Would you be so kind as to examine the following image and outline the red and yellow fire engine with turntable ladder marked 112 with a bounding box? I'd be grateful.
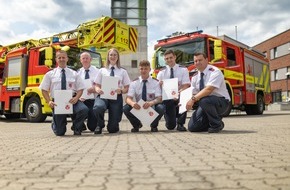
[0,17,138,122]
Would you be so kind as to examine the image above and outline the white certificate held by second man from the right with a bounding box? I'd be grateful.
[162,78,178,100]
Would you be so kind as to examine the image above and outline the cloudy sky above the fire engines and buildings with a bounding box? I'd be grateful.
[0,0,290,60]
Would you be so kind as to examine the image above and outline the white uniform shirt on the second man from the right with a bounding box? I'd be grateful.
[157,64,190,89]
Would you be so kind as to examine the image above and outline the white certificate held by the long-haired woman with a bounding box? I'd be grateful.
[100,76,119,100]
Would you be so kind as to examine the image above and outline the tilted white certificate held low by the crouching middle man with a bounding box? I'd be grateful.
[131,99,158,126]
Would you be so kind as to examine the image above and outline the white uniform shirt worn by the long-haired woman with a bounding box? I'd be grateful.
[94,66,131,88]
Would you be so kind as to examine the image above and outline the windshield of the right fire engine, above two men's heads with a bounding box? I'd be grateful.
[155,39,206,68]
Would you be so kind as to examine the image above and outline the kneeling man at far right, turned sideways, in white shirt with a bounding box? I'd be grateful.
[186,53,231,133]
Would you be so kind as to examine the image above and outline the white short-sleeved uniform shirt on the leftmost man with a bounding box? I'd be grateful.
[39,67,85,98]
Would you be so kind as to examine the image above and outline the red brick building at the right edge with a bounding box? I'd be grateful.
[253,29,290,102]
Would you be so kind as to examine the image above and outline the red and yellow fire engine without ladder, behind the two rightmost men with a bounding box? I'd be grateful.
[151,31,272,116]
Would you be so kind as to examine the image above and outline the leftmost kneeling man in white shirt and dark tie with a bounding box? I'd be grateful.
[39,50,88,136]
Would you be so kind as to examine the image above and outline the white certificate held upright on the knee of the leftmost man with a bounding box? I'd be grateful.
[54,90,73,114]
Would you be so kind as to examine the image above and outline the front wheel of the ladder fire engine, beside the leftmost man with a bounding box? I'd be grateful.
[25,97,47,123]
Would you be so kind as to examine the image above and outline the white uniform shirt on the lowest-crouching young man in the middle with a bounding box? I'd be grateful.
[127,77,161,102]
